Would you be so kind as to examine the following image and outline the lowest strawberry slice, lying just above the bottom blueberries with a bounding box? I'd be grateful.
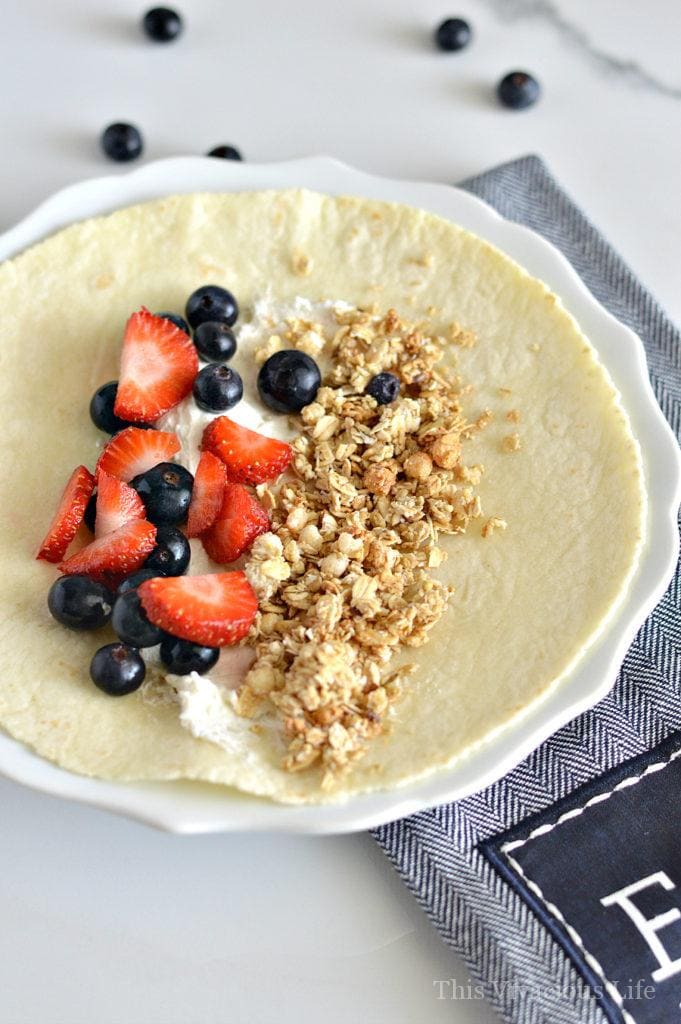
[137,572,258,647]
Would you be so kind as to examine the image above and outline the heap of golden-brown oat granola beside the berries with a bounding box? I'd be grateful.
[236,309,491,787]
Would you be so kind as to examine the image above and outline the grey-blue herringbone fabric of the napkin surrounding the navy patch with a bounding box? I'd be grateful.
[375,157,681,1024]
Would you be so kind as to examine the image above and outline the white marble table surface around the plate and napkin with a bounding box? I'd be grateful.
[0,0,681,1024]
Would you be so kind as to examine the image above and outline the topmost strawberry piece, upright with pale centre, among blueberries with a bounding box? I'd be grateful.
[114,306,199,423]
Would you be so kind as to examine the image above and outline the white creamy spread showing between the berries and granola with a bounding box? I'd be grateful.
[141,296,349,753]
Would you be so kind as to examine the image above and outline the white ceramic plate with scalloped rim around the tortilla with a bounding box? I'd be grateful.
[0,157,681,833]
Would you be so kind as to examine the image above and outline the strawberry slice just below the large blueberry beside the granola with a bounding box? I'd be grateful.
[201,416,293,483]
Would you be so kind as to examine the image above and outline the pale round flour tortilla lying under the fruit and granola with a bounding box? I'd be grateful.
[0,190,644,802]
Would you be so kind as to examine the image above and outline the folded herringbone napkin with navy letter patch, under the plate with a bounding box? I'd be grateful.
[375,156,681,1024]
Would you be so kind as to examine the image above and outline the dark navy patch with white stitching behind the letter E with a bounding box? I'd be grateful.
[480,732,681,1024]
